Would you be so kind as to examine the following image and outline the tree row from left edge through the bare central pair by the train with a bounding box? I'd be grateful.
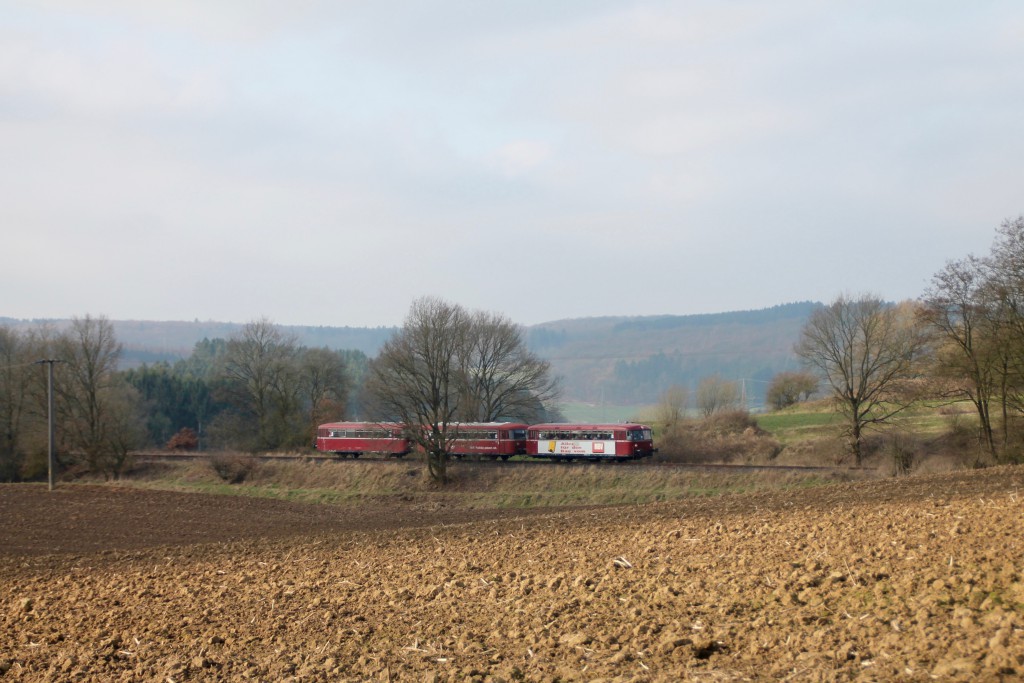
[0,299,556,481]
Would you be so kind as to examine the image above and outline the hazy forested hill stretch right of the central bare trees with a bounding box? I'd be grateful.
[528,301,820,407]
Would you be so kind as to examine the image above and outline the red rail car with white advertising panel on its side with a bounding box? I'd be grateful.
[526,422,654,461]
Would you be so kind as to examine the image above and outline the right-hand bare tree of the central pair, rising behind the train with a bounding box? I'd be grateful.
[460,311,558,422]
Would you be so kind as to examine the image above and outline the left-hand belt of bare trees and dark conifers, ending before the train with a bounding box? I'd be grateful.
[0,315,366,480]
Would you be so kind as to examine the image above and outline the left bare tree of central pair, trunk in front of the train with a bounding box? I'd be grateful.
[367,297,470,483]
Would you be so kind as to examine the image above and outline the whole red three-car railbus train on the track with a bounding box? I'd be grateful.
[315,422,655,461]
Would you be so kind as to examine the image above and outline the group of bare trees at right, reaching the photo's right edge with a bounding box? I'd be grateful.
[796,216,1024,464]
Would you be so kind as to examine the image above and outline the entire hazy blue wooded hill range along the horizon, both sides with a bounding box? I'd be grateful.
[0,301,820,408]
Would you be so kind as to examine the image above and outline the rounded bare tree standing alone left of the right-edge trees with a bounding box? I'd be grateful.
[796,295,926,465]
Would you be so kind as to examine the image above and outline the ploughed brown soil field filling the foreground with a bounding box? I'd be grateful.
[0,468,1024,681]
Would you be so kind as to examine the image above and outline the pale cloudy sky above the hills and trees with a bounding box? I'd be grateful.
[0,0,1024,327]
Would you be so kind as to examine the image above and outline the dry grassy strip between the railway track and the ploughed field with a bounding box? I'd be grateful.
[122,460,871,508]
